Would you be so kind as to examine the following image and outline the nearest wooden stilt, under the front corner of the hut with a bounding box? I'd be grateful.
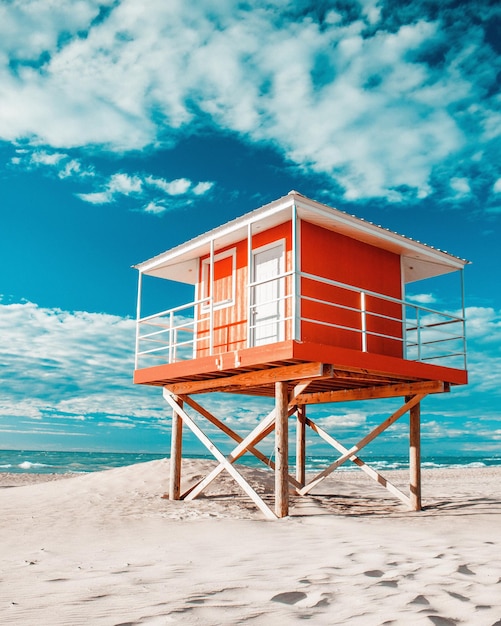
[275,382,289,517]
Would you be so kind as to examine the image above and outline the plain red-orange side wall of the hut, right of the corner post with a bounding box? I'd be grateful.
[301,222,402,356]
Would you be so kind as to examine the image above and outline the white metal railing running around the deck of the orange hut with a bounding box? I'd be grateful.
[136,272,466,369]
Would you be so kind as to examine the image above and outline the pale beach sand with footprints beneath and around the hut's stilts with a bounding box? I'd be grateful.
[0,461,501,626]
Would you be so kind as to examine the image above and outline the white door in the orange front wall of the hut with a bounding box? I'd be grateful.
[250,242,285,346]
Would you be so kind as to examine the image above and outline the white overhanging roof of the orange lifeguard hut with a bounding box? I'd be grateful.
[134,191,468,284]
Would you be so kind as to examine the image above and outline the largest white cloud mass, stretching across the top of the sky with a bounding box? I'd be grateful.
[0,0,499,201]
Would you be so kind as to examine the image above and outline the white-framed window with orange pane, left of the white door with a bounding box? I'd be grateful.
[202,248,236,311]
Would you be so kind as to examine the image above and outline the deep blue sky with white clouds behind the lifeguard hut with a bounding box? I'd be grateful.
[0,0,501,455]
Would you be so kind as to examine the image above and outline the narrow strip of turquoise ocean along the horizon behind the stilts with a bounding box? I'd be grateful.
[0,450,501,474]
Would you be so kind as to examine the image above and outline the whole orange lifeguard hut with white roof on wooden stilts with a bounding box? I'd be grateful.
[134,191,467,518]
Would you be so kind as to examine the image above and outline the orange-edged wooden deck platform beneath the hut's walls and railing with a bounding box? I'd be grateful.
[134,341,468,394]
